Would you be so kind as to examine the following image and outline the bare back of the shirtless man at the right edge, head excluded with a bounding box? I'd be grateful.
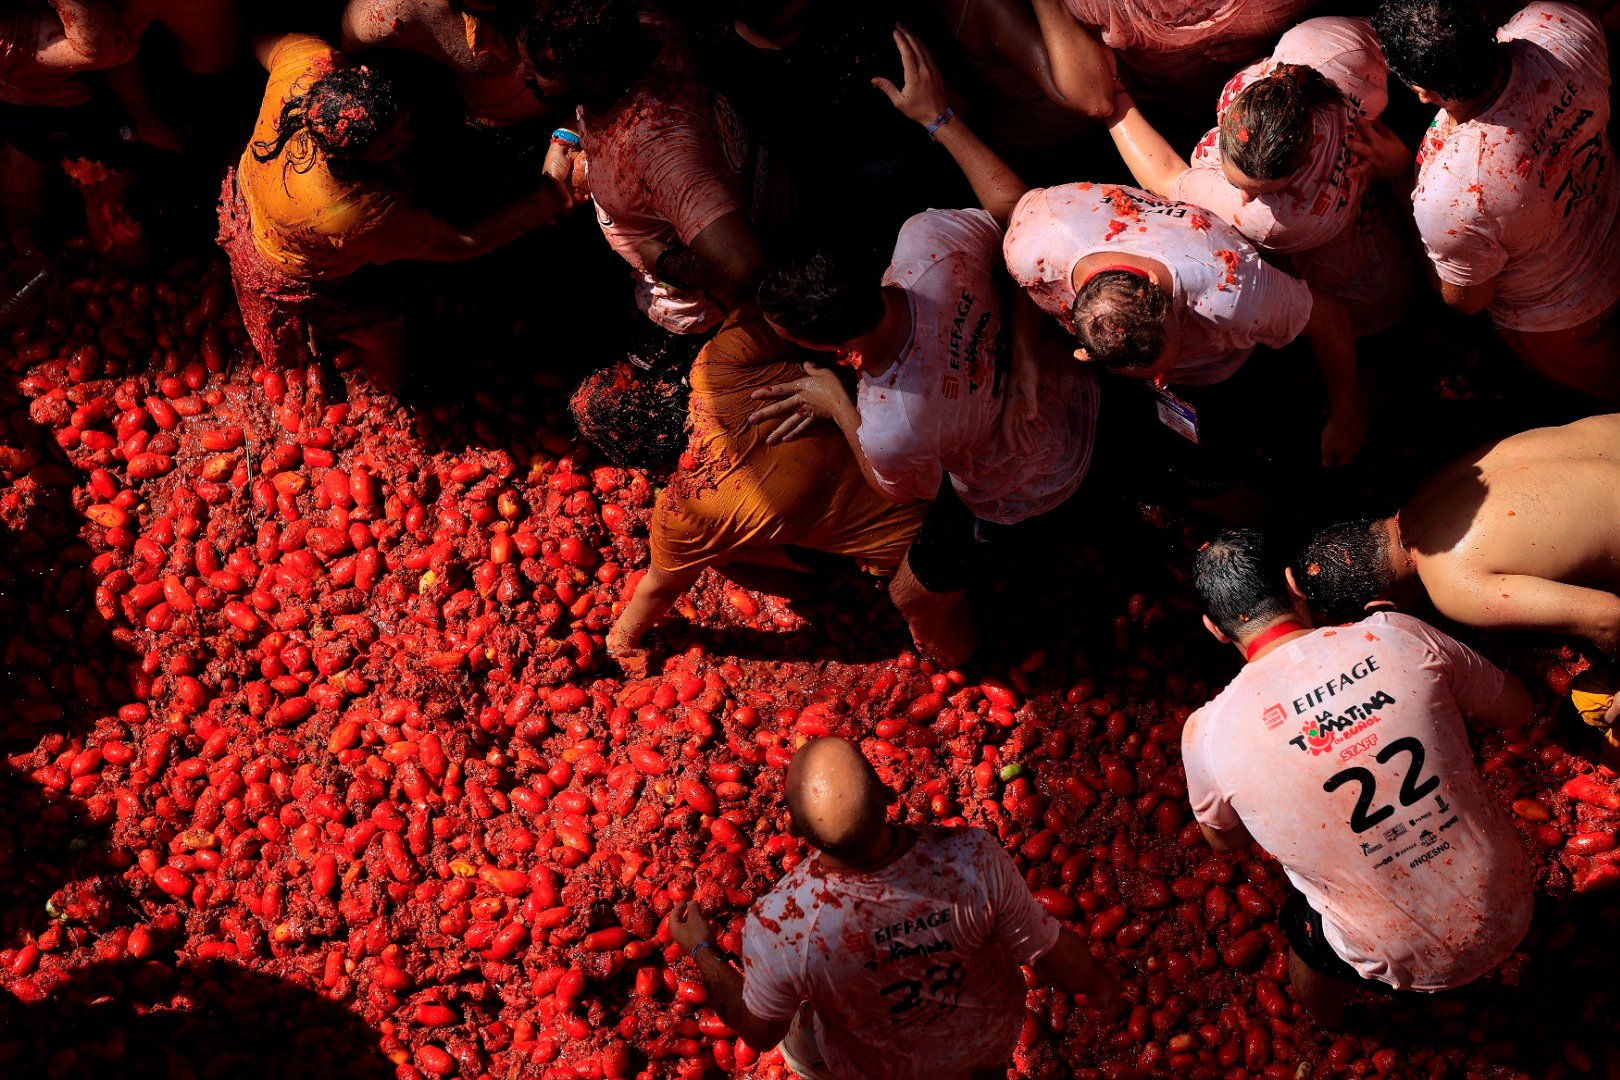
[1401,415,1620,649]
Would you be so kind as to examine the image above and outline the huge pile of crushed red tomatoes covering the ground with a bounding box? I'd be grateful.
[0,244,1620,1080]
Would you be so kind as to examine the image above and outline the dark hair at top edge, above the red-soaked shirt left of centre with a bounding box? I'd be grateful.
[517,0,658,107]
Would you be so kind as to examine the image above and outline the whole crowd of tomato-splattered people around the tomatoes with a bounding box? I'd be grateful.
[0,0,1620,1078]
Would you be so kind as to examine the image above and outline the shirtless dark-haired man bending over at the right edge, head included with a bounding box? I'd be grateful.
[1294,415,1620,656]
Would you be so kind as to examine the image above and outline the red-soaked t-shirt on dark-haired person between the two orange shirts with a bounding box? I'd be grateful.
[578,15,758,334]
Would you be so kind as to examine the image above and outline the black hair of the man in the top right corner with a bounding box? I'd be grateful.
[1372,0,1502,100]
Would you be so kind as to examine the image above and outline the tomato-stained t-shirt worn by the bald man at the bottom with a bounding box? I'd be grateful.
[742,827,1059,1080]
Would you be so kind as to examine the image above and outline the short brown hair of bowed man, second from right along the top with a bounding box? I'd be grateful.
[1220,63,1345,181]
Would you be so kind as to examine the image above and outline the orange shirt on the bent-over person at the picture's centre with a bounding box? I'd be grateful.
[651,309,928,575]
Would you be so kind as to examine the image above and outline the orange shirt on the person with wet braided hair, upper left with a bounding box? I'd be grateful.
[237,34,434,280]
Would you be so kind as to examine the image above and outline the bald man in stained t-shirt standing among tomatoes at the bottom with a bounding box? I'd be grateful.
[669,738,1119,1080]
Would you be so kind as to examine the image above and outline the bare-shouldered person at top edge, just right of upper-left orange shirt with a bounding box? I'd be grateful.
[342,0,552,128]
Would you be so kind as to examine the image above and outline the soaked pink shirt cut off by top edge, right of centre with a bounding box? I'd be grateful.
[1064,0,1315,89]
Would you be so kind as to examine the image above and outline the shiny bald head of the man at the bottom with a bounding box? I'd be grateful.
[786,737,893,868]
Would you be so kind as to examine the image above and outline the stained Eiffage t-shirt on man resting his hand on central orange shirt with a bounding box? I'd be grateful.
[855,209,1098,525]
